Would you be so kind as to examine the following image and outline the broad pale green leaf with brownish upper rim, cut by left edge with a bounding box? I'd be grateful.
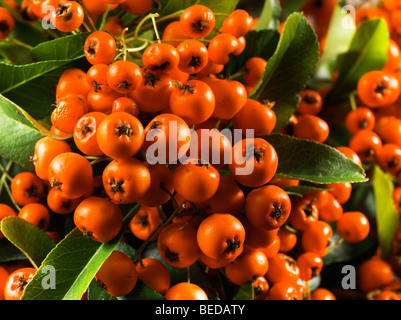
[0,95,46,171]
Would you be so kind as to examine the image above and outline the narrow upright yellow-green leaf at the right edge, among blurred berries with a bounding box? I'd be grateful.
[372,165,400,258]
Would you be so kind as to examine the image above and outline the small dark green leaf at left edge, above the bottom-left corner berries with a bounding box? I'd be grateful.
[1,216,56,268]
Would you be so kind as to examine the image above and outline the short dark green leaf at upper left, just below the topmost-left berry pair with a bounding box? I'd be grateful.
[32,33,90,61]
